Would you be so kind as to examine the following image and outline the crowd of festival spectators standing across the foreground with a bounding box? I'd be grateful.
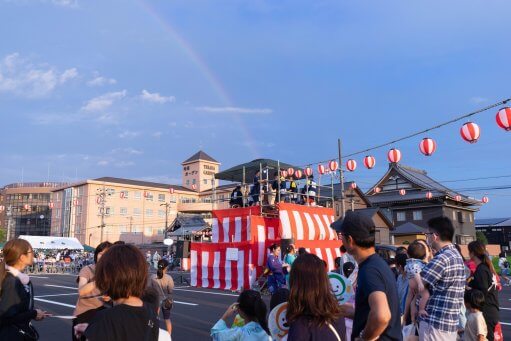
[0,212,506,341]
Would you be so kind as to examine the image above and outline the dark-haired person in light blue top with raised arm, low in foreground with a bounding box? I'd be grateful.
[211,290,271,341]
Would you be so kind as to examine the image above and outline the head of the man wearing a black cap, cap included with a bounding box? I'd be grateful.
[331,211,376,254]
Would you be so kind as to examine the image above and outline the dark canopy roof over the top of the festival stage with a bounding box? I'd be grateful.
[215,159,298,183]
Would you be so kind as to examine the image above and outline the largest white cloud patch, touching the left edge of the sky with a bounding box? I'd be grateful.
[0,53,78,98]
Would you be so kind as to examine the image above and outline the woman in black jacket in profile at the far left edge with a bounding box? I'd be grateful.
[0,239,49,341]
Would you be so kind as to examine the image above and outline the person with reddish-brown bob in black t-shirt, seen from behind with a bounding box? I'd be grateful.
[75,245,159,341]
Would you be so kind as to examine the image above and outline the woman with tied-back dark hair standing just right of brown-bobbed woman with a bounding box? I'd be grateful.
[151,259,174,334]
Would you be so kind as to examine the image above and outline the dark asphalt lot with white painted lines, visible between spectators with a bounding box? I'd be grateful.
[31,273,511,341]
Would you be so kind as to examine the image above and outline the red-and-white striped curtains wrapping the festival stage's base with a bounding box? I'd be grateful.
[191,203,341,290]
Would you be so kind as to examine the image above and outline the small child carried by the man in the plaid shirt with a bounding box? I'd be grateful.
[405,241,430,323]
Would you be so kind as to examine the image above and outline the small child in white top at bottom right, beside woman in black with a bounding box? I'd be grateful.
[464,289,488,341]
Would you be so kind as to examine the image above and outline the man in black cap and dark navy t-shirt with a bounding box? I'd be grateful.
[331,212,402,341]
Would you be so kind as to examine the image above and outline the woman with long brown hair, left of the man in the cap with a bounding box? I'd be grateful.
[287,254,346,341]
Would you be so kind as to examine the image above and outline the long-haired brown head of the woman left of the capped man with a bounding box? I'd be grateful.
[287,253,340,326]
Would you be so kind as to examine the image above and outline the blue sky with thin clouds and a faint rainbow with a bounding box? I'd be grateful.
[0,0,511,217]
